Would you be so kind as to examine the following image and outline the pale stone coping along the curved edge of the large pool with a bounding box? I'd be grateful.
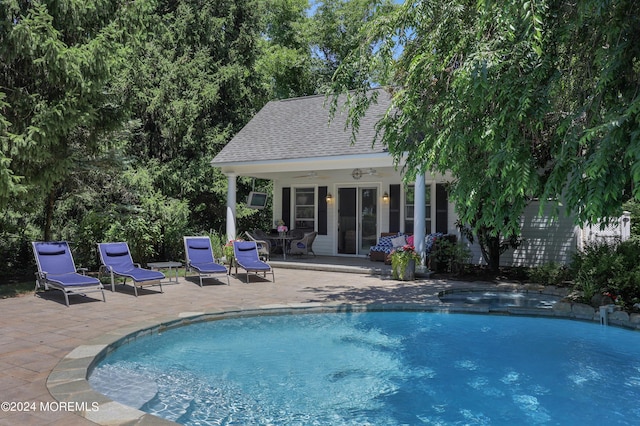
[46,298,640,425]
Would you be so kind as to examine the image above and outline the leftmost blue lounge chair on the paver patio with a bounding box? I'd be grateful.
[31,241,107,307]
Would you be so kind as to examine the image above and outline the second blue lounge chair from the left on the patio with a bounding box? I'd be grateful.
[98,242,165,297]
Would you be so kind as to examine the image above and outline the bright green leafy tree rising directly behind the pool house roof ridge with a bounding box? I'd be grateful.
[257,0,395,100]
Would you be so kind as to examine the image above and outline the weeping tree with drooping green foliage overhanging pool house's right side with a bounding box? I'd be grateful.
[334,0,640,269]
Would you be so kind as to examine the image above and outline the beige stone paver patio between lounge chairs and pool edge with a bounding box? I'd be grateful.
[0,266,608,425]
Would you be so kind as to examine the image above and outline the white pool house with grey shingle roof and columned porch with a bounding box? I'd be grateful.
[211,92,444,268]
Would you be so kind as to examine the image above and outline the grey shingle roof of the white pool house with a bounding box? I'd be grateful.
[211,91,390,165]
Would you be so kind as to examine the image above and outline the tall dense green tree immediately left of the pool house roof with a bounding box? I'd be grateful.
[116,0,265,235]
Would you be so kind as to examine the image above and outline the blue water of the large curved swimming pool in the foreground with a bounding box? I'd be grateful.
[89,312,640,425]
